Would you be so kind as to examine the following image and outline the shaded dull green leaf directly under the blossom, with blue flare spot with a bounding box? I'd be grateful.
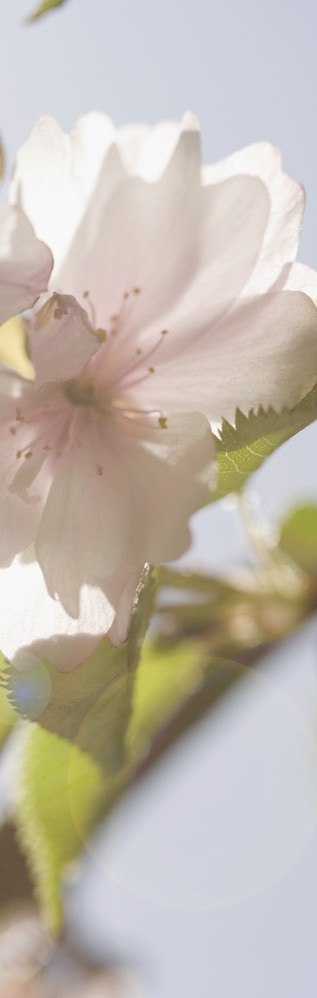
[6,566,155,776]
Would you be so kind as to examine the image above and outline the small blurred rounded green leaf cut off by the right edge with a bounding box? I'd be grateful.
[279,504,317,575]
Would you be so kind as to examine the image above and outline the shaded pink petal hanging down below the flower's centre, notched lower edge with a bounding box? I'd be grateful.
[36,413,213,630]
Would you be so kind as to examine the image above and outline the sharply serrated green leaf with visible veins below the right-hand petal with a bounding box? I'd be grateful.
[211,386,317,501]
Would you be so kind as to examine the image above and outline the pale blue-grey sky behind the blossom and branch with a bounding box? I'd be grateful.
[0,0,317,998]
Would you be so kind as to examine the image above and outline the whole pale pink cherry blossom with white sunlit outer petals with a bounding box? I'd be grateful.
[0,113,317,670]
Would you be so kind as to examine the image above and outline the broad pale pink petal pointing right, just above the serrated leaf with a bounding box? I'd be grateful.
[133,291,317,422]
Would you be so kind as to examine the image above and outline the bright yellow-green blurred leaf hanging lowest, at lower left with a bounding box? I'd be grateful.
[14,724,102,932]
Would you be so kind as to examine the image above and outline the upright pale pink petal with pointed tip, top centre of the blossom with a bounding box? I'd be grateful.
[53,114,203,328]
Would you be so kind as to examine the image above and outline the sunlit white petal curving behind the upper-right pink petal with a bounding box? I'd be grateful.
[203,142,305,296]
